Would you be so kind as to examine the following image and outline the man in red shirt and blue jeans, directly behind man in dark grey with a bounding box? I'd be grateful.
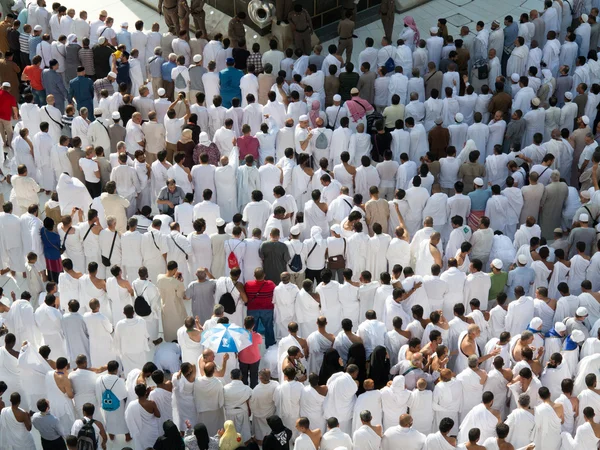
[244,267,275,348]
